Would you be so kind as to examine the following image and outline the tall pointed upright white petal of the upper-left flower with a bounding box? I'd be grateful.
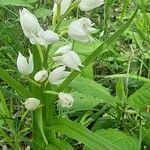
[20,8,42,38]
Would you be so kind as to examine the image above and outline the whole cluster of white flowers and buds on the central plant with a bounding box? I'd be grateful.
[17,0,103,110]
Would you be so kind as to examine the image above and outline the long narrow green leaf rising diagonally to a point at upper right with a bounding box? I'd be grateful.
[57,9,138,92]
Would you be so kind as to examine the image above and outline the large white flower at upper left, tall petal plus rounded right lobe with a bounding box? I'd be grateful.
[20,8,59,47]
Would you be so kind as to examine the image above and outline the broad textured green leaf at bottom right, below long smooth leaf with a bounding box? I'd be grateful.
[85,129,139,150]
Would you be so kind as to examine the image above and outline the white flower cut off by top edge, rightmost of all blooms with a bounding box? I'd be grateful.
[78,0,104,11]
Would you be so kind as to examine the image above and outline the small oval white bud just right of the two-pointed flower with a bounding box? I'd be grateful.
[34,70,48,82]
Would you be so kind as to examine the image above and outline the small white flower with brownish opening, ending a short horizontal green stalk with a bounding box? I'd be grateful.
[58,92,74,108]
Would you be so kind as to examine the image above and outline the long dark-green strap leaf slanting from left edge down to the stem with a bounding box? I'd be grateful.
[0,67,32,98]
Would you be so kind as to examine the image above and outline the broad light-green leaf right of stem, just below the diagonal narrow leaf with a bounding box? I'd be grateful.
[69,77,114,102]
